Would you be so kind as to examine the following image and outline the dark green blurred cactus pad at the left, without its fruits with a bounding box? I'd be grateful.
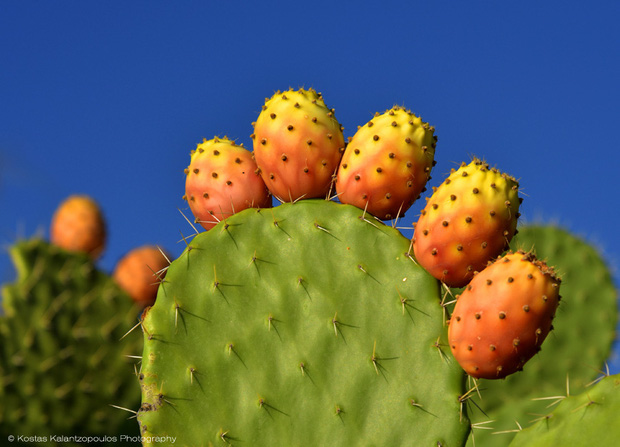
[0,239,142,439]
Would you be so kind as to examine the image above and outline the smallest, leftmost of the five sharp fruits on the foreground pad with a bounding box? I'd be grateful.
[183,137,271,230]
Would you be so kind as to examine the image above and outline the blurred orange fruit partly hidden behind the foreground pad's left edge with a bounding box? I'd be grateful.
[113,245,170,307]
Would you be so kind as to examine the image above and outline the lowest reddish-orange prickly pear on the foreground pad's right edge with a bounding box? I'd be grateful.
[448,251,560,379]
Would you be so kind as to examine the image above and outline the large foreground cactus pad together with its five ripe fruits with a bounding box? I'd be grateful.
[138,89,616,446]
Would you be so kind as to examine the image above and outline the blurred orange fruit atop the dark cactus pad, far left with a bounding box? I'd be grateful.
[50,195,106,259]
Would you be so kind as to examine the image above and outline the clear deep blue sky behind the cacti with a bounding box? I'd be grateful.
[0,0,620,371]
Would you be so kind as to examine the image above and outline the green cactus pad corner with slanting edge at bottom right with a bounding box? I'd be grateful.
[510,375,620,447]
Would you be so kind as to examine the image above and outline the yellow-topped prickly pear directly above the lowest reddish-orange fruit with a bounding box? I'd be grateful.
[413,159,521,287]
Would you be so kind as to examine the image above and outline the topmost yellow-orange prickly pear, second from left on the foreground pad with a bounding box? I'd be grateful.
[252,89,344,202]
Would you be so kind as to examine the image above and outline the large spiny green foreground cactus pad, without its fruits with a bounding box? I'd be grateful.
[138,200,469,446]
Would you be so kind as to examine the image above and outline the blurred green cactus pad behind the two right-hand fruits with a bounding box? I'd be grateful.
[469,225,617,447]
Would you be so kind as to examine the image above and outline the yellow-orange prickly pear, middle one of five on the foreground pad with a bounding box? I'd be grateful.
[336,107,437,220]
